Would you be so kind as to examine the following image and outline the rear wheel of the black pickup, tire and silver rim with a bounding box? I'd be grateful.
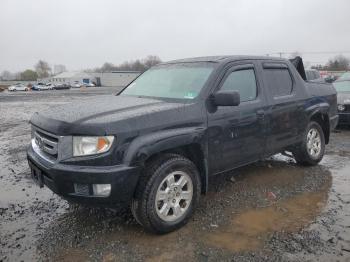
[293,121,325,166]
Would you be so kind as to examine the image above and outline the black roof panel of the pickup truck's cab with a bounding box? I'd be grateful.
[162,55,286,64]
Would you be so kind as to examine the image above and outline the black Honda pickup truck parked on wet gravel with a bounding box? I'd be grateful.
[27,56,338,233]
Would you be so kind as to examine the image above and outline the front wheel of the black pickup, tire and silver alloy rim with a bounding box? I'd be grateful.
[131,154,201,234]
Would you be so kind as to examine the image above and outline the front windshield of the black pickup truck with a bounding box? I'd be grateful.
[121,63,214,99]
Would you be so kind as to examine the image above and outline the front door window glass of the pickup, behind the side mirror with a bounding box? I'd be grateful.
[220,69,257,102]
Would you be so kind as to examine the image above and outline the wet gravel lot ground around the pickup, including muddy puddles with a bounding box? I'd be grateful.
[0,88,350,261]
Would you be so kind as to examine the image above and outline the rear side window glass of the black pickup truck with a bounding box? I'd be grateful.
[264,68,293,97]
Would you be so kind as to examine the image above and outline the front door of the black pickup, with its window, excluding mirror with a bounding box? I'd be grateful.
[208,63,267,174]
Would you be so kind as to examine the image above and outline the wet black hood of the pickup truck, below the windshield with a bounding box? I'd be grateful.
[30,96,200,135]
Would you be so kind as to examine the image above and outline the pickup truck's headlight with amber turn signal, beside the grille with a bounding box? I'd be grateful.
[73,136,114,156]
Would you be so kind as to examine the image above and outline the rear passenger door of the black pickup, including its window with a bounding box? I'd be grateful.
[261,61,304,155]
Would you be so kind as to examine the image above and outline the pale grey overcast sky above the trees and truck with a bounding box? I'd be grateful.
[0,0,350,71]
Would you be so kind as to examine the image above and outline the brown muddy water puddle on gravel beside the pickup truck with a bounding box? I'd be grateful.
[205,180,330,252]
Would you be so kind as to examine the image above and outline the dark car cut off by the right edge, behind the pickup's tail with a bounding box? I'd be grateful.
[333,73,350,125]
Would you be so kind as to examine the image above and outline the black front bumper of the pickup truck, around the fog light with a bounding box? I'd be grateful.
[27,146,140,206]
